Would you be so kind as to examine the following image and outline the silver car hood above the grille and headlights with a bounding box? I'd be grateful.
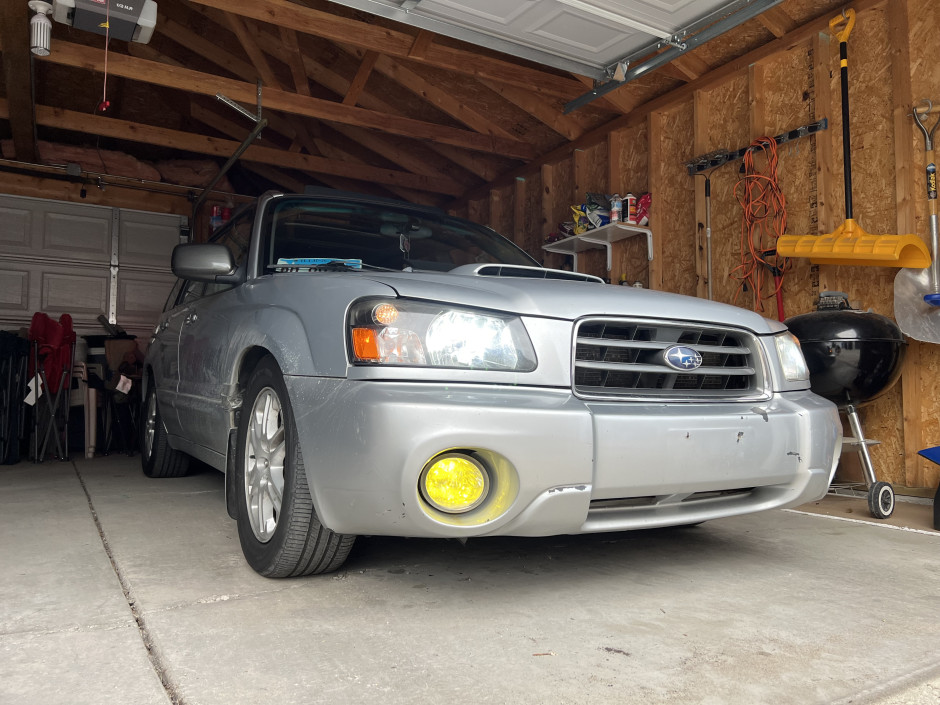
[363,272,785,334]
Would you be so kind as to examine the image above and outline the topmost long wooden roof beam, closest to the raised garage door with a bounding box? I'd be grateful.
[185,0,583,100]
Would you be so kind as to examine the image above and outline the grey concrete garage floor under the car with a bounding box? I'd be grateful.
[0,456,940,705]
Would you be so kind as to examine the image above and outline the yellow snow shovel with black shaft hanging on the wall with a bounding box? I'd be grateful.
[777,10,930,269]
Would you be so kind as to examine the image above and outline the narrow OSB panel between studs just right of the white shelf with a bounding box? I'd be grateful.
[650,100,697,296]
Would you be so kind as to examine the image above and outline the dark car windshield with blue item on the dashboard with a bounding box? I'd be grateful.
[262,197,539,272]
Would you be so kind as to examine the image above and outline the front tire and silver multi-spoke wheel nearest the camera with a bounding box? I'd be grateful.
[233,357,356,578]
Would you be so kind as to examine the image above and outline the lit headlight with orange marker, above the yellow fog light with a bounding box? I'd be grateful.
[349,299,536,372]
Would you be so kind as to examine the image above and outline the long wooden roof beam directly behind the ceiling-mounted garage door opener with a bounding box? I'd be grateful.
[43,42,535,160]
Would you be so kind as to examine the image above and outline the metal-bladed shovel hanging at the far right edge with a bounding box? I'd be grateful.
[894,99,940,343]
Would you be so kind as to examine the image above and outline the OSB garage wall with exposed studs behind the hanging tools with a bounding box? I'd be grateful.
[458,0,940,492]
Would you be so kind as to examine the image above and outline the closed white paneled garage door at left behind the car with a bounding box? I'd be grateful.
[0,195,182,337]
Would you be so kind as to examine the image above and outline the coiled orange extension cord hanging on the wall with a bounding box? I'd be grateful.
[730,137,790,321]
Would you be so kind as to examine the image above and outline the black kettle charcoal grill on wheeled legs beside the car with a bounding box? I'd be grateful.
[786,309,907,519]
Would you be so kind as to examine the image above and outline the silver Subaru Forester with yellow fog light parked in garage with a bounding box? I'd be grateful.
[141,191,842,577]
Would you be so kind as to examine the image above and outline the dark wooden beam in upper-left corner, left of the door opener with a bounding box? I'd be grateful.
[0,0,39,164]
